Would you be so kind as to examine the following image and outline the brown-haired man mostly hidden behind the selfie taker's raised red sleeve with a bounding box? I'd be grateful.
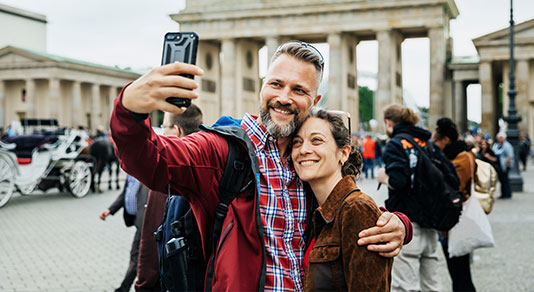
[135,104,202,292]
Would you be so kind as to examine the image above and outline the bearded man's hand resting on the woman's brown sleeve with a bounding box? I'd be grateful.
[358,212,406,258]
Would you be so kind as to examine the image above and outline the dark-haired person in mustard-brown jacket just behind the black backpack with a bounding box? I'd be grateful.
[440,140,477,292]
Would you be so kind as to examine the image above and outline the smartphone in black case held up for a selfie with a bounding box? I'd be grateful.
[161,32,198,107]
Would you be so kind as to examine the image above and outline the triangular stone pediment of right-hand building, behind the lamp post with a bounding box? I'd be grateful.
[473,19,534,46]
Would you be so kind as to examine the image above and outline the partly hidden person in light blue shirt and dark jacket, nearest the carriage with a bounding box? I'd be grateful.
[100,175,148,292]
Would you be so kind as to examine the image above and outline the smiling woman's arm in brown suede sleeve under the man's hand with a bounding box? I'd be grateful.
[340,199,393,291]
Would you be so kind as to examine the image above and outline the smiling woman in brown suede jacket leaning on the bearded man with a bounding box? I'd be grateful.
[291,108,393,291]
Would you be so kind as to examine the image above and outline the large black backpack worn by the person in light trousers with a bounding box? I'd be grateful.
[397,134,462,231]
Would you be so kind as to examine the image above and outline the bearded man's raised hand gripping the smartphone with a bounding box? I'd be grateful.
[122,63,204,114]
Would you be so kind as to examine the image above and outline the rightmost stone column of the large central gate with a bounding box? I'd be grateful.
[428,27,448,129]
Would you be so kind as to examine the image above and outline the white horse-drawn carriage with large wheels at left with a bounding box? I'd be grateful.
[0,119,92,207]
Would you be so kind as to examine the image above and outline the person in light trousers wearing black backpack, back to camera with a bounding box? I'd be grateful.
[377,105,462,291]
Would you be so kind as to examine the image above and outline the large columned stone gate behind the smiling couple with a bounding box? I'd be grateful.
[171,0,458,130]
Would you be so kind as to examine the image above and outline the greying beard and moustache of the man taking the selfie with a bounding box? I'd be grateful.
[260,101,300,138]
